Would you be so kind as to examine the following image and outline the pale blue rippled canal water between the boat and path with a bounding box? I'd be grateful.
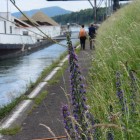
[0,30,78,107]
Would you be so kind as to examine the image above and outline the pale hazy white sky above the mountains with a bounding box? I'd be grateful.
[0,0,104,12]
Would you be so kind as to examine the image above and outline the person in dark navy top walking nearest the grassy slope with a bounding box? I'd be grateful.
[88,24,96,49]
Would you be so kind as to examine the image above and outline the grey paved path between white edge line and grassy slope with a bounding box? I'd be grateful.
[2,40,94,140]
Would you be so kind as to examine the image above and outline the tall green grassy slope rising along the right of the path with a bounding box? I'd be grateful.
[88,0,140,140]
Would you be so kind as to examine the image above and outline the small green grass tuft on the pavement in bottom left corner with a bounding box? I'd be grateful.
[0,126,21,135]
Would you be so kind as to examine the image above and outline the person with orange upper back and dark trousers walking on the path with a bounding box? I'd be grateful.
[79,25,87,50]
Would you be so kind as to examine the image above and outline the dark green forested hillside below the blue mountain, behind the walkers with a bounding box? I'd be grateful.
[53,8,106,25]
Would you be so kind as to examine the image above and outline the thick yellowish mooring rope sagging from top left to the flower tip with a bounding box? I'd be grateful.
[10,0,67,47]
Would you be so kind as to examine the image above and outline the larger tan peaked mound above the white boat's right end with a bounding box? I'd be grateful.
[32,11,59,26]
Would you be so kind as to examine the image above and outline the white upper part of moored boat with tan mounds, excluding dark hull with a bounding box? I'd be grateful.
[0,12,61,45]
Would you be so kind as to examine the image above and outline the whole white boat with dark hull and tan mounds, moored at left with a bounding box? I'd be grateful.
[0,12,61,60]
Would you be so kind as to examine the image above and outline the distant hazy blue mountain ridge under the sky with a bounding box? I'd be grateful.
[12,6,72,18]
